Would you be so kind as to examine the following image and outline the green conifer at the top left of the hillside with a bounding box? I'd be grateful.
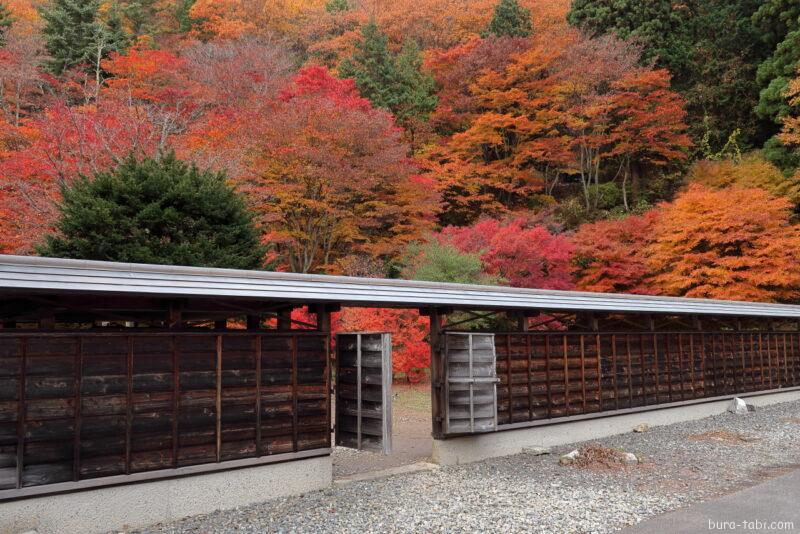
[40,0,127,74]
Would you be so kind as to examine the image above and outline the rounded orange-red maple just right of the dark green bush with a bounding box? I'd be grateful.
[239,67,435,272]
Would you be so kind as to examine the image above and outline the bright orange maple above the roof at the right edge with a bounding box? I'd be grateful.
[647,184,800,302]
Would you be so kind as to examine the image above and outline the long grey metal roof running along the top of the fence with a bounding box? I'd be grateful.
[0,255,800,318]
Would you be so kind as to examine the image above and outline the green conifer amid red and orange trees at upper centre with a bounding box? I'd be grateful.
[339,22,437,131]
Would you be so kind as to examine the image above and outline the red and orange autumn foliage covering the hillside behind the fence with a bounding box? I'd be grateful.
[0,0,800,350]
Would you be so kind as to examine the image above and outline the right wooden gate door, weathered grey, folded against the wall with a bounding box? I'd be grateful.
[444,332,498,434]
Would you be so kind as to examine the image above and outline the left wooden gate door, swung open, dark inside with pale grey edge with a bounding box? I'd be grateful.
[335,332,392,454]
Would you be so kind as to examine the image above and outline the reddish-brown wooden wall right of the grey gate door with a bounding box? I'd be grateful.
[495,332,800,425]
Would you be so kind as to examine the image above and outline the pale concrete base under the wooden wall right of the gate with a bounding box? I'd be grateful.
[433,391,800,465]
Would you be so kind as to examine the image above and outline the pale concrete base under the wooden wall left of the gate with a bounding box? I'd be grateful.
[0,456,332,534]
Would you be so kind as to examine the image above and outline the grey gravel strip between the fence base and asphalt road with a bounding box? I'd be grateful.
[130,402,800,533]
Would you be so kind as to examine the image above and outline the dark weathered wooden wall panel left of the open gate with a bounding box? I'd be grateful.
[0,332,330,496]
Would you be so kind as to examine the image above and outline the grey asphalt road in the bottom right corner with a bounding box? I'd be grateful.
[622,470,800,534]
